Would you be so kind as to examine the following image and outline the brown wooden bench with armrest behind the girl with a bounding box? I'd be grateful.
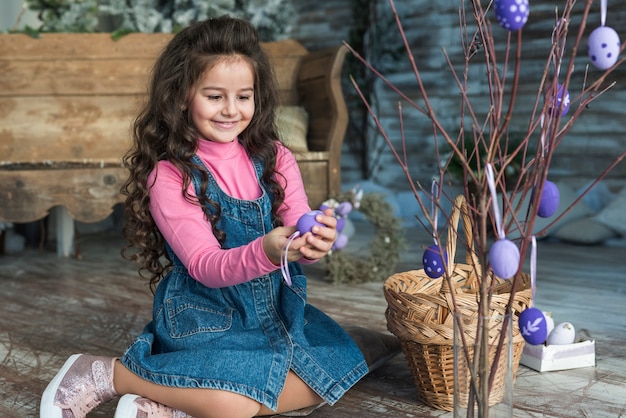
[0,33,348,255]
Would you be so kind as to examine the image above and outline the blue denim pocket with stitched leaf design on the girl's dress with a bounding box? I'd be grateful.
[166,297,233,338]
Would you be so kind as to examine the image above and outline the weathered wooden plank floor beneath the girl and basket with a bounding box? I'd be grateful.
[0,222,626,418]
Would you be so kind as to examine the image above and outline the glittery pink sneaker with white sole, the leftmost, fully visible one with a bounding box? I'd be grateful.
[39,354,117,418]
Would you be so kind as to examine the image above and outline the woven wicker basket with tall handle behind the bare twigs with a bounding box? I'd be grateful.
[383,196,532,411]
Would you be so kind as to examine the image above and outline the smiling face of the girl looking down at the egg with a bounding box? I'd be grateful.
[189,56,255,143]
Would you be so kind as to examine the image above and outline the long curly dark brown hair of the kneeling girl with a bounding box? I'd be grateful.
[121,17,285,290]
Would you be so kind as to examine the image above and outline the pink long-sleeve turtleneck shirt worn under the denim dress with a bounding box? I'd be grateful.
[148,139,310,287]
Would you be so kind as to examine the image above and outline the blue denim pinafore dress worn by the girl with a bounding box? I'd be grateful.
[122,156,368,410]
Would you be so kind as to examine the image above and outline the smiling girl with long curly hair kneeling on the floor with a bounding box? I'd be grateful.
[41,17,397,418]
